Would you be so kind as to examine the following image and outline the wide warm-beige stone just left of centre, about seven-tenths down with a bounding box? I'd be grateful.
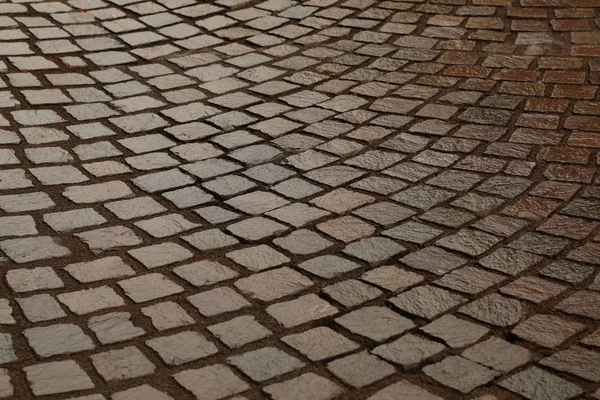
[235,267,314,301]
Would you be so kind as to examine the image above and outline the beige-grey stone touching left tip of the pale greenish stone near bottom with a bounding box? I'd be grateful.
[146,331,218,365]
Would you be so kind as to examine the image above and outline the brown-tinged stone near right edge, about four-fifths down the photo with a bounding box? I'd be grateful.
[512,314,585,348]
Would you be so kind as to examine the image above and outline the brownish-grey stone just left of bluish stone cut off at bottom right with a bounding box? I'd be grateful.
[423,356,499,394]
